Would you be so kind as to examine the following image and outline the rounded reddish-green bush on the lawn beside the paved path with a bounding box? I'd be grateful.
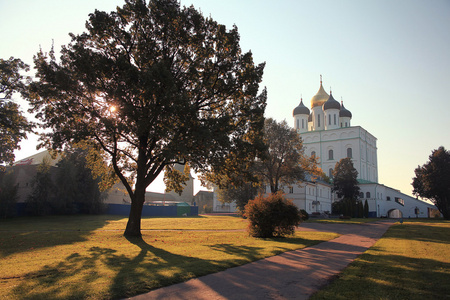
[245,192,301,238]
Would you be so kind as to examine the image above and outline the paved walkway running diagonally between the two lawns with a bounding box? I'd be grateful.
[127,220,394,300]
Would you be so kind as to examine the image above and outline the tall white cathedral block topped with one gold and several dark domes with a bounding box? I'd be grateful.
[293,76,378,183]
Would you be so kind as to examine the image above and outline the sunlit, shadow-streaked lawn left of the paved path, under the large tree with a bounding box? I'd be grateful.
[0,216,337,299]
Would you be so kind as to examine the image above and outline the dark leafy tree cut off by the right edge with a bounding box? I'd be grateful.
[412,146,450,220]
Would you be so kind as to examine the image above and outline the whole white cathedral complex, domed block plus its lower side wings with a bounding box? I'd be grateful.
[214,76,436,218]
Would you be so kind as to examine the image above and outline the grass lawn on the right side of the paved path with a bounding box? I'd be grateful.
[311,219,450,300]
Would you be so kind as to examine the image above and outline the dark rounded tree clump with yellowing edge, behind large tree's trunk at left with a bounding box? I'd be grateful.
[26,143,114,215]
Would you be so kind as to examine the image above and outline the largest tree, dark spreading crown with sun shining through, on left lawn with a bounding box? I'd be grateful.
[30,0,266,236]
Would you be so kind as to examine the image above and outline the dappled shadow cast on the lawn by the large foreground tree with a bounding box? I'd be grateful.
[6,238,250,299]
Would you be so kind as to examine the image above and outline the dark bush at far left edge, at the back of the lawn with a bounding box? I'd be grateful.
[0,171,18,219]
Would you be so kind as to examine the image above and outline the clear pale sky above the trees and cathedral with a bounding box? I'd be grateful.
[0,0,450,194]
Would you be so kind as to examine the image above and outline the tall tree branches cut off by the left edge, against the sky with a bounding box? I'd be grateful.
[0,57,33,167]
